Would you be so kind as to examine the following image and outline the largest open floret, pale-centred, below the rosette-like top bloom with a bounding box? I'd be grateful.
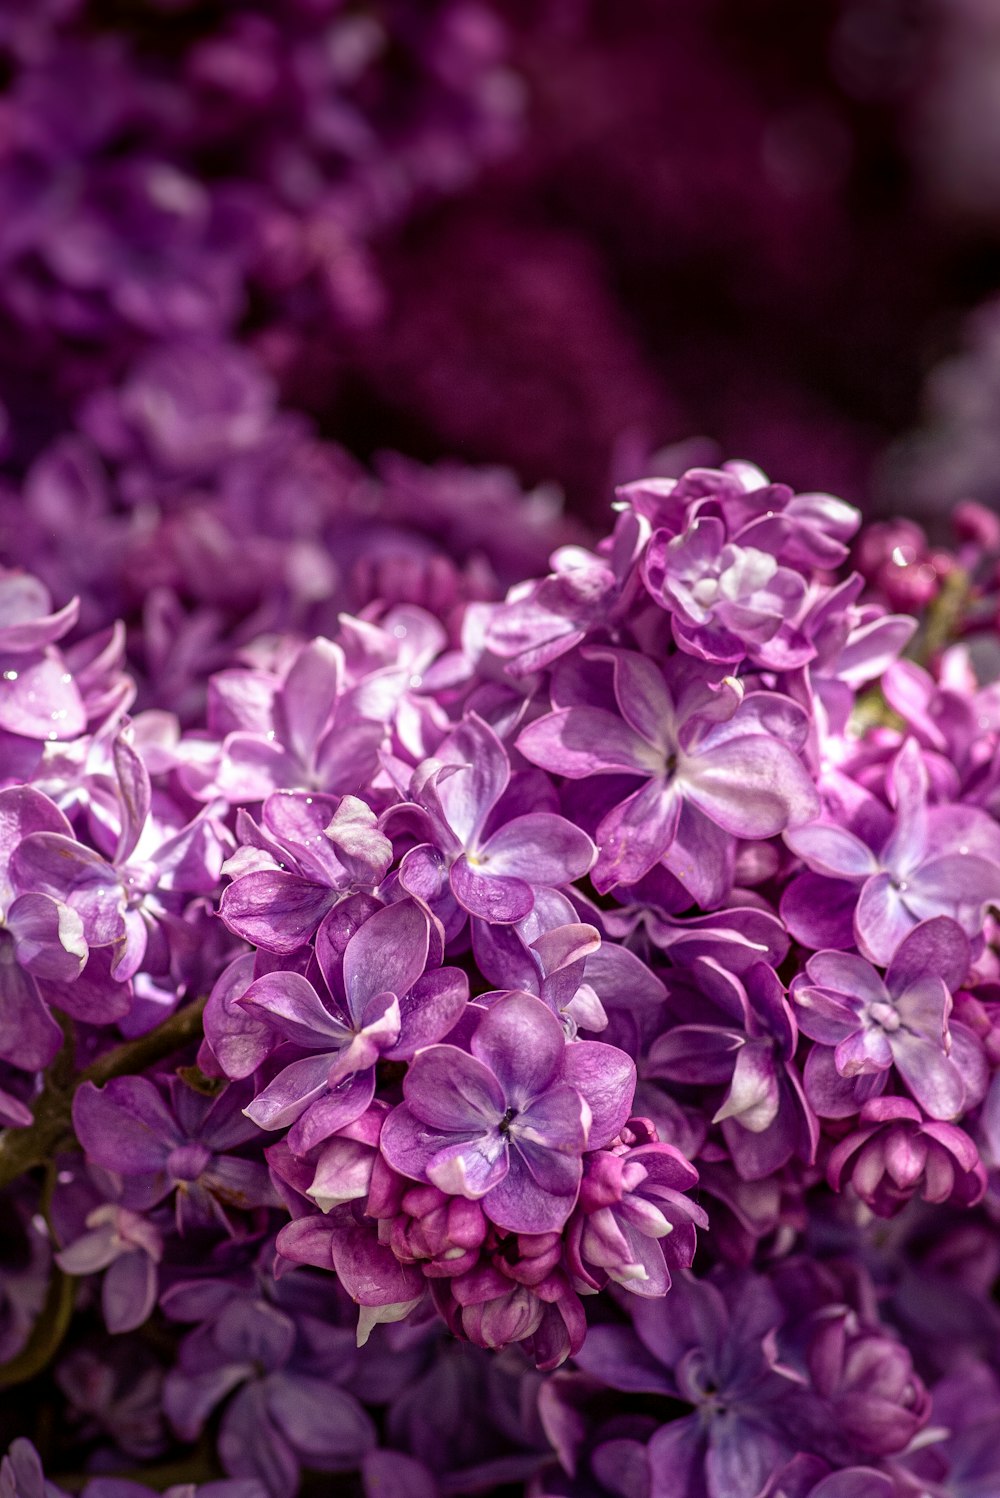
[518,650,817,906]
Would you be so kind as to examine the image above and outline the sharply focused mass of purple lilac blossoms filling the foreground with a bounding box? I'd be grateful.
[0,449,1000,1498]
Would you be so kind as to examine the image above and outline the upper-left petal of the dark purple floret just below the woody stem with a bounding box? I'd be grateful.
[73,1077,184,1176]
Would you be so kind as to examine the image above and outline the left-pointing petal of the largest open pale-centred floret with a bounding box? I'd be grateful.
[518,707,665,780]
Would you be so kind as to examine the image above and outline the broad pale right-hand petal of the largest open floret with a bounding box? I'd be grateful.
[678,734,819,837]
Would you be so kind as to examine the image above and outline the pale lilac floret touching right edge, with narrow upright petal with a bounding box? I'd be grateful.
[781,739,1000,966]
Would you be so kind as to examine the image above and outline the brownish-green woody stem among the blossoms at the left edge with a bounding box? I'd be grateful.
[0,998,205,1188]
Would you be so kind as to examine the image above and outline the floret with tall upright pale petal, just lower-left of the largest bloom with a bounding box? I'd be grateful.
[383,713,594,927]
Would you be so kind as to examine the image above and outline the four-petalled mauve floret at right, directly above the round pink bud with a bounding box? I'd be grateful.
[792,915,987,1119]
